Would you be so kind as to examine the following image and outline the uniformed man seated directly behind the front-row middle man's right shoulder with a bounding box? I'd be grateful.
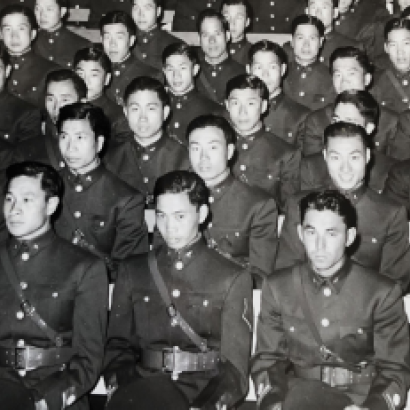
[187,115,278,287]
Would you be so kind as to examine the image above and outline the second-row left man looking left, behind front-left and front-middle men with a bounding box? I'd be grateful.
[56,103,148,280]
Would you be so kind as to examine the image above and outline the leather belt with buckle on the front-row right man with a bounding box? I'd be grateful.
[295,366,376,387]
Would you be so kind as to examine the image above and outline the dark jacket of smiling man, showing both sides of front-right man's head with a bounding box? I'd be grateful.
[275,185,410,293]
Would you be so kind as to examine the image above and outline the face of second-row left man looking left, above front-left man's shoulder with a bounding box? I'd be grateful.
[58,120,104,174]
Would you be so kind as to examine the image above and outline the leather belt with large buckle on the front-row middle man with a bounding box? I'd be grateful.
[141,346,220,373]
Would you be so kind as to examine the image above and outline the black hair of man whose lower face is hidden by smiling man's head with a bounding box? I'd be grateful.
[334,90,379,125]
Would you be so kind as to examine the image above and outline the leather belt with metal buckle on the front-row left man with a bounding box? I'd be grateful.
[0,346,74,370]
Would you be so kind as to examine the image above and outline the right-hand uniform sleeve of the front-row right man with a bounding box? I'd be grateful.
[363,285,410,410]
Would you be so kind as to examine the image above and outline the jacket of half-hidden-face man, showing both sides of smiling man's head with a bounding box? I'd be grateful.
[301,104,403,158]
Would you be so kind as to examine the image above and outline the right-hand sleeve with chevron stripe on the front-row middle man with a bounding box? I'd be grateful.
[192,272,253,410]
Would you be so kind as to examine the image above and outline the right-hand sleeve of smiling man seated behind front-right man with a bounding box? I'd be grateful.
[380,207,410,293]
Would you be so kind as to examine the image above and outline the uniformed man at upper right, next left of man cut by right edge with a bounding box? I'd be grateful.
[283,15,334,110]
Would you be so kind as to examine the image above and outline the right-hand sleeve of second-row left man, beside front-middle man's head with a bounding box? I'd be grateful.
[111,194,148,260]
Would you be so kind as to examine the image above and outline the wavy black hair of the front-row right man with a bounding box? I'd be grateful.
[299,189,357,229]
